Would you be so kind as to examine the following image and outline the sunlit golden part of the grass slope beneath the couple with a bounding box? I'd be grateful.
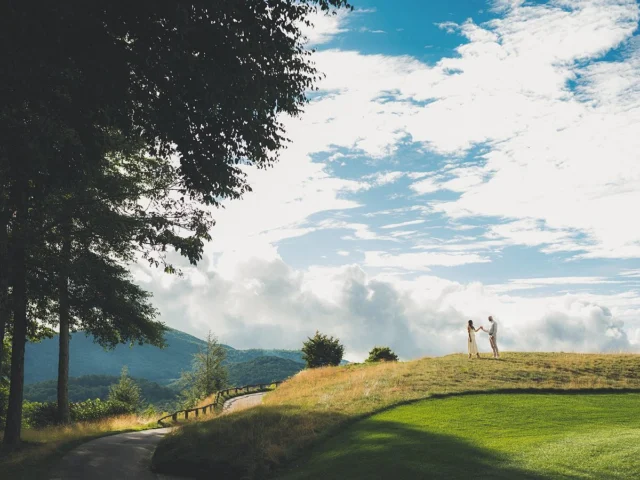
[264,353,640,416]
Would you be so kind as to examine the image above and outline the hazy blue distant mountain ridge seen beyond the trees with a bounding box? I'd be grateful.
[25,329,304,385]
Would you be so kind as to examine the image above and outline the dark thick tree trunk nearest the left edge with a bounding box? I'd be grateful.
[4,180,29,447]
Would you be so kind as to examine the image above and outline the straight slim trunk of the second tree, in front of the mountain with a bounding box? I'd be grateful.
[58,221,71,423]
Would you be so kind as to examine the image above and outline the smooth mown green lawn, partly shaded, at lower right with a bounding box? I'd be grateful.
[277,394,640,480]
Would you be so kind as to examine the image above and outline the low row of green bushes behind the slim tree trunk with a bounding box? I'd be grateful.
[22,399,134,428]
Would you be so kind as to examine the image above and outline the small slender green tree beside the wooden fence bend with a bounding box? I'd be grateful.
[180,332,228,407]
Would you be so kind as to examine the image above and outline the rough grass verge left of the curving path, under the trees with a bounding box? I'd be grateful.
[0,415,158,480]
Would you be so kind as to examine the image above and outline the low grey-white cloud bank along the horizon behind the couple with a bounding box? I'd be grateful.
[140,258,640,360]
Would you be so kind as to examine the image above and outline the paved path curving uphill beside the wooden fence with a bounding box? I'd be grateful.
[49,393,264,480]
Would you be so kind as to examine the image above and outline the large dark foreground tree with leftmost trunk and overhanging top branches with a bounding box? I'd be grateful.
[0,0,348,445]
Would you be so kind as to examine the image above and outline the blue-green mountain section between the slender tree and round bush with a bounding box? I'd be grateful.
[228,356,304,386]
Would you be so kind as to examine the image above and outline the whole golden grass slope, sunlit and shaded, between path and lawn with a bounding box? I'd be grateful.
[154,353,640,478]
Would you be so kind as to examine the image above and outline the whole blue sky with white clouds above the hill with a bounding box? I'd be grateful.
[134,0,640,361]
